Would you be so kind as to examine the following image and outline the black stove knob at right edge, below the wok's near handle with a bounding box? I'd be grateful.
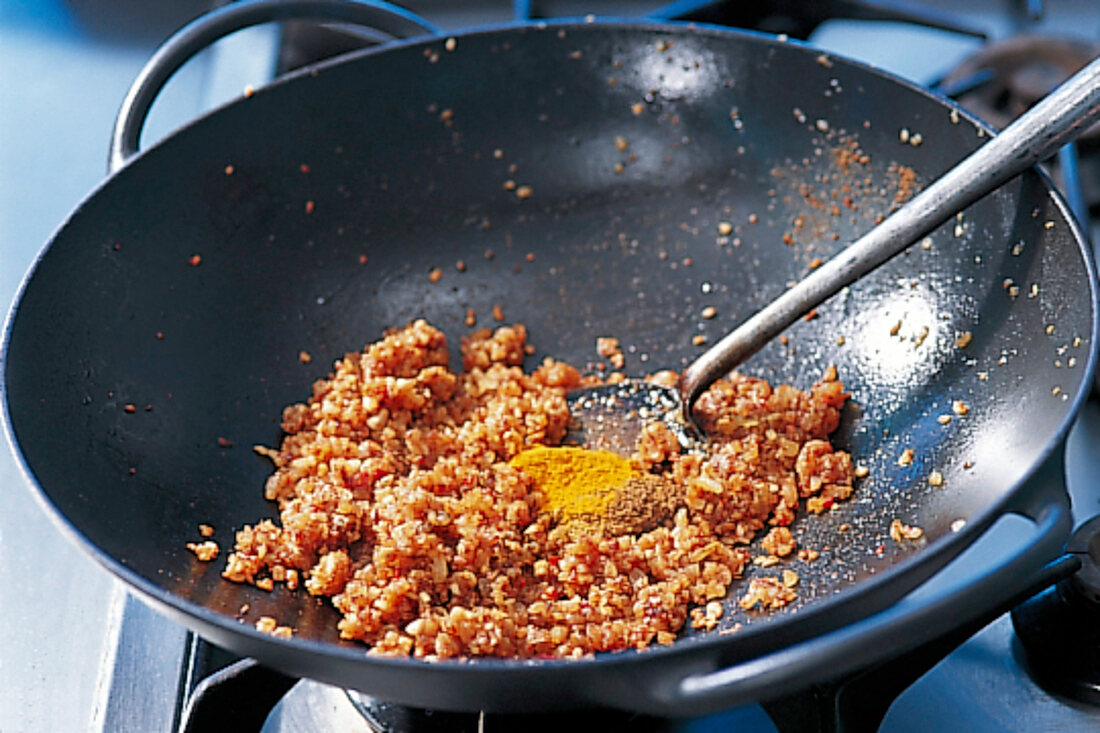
[1012,516,1100,705]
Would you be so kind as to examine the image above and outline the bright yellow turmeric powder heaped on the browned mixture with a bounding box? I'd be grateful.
[509,446,635,522]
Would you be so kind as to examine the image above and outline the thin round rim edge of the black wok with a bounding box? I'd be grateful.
[0,18,1100,676]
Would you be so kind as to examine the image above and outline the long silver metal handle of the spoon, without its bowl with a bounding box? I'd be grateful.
[680,58,1100,412]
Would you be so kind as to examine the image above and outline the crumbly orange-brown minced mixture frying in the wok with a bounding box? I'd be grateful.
[223,321,853,658]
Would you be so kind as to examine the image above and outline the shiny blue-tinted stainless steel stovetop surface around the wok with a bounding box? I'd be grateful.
[0,0,1100,733]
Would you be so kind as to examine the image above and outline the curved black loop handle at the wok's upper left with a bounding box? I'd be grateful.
[107,0,440,173]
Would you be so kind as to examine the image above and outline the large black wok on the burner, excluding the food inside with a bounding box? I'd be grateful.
[3,3,1097,713]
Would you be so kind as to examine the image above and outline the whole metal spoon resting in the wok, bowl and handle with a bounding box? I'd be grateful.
[567,58,1100,455]
